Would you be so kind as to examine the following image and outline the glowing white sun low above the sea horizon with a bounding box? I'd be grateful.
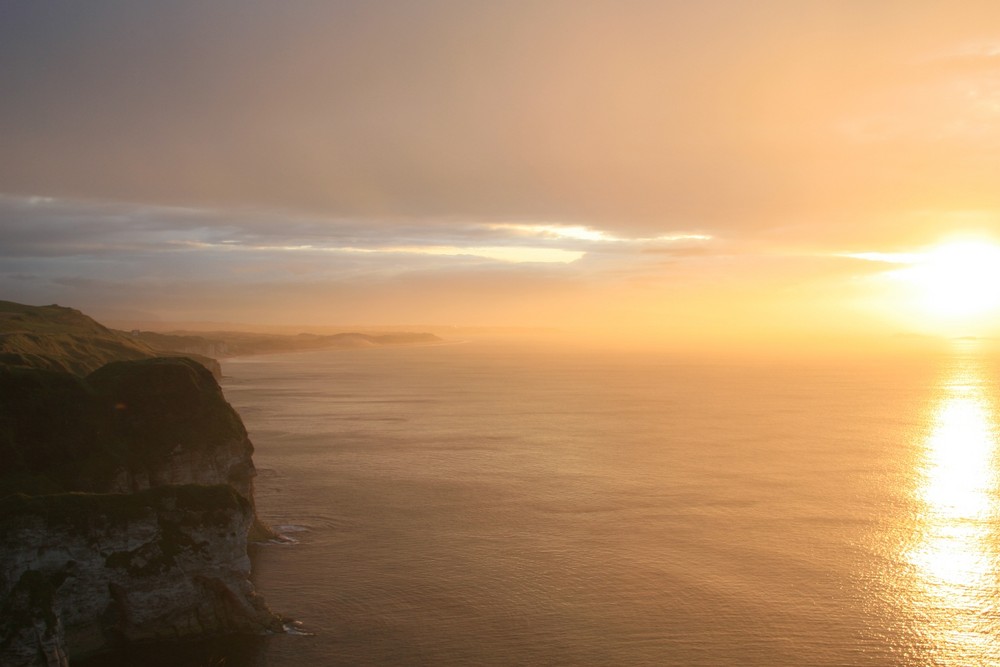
[901,240,1000,320]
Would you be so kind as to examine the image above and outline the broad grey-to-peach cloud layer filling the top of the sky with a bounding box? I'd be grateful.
[0,0,1000,233]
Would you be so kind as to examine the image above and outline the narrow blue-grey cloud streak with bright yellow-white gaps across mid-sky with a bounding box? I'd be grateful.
[0,195,711,262]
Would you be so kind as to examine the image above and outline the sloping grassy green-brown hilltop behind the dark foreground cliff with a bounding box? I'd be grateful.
[0,301,220,377]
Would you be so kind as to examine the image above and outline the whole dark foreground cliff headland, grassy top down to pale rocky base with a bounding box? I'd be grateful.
[0,359,281,665]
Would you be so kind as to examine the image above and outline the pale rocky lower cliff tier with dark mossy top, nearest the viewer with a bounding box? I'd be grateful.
[0,485,281,665]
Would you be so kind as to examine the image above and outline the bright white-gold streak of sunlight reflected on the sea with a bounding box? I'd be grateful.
[907,360,1000,665]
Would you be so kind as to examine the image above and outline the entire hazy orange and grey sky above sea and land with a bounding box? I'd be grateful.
[0,0,1000,345]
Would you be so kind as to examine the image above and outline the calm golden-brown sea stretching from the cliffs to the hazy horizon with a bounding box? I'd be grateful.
[92,342,1000,667]
